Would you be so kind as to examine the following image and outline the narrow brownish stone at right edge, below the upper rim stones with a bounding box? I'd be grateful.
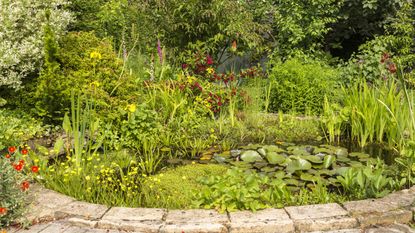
[357,210,413,227]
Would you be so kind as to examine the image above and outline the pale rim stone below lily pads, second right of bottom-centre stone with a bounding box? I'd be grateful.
[285,203,358,232]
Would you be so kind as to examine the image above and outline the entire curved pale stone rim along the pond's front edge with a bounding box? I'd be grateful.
[17,186,415,233]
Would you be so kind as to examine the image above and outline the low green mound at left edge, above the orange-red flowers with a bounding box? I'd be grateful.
[0,109,44,150]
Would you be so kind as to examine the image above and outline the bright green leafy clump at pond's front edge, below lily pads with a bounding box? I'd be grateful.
[195,168,290,212]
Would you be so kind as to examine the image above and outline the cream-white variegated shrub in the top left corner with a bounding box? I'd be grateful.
[0,0,71,88]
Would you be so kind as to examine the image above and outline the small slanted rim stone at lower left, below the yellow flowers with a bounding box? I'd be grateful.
[55,201,109,220]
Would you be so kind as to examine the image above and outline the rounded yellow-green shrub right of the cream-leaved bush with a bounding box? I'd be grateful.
[34,32,134,122]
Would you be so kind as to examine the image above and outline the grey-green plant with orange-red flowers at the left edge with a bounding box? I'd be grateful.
[0,146,39,227]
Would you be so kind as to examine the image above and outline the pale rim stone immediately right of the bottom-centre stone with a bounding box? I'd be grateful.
[229,209,294,233]
